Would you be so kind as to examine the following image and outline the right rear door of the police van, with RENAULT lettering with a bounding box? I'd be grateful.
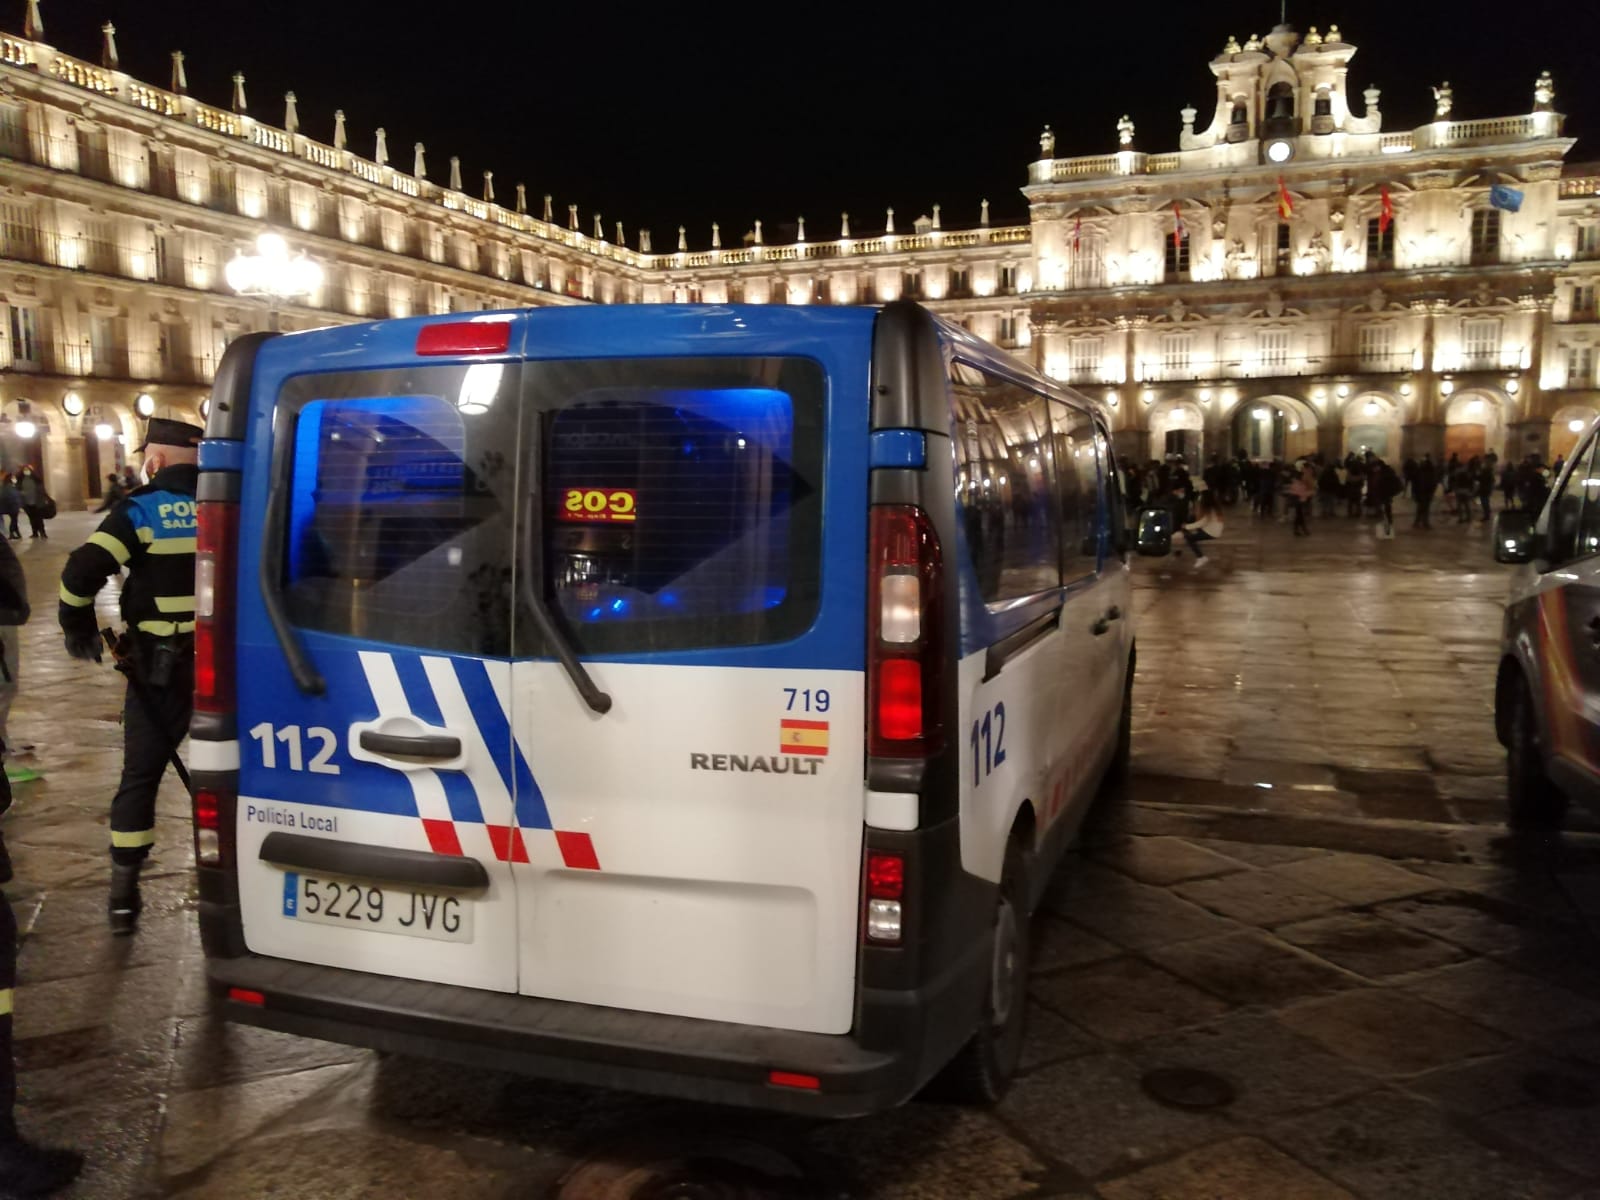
[510,345,870,1034]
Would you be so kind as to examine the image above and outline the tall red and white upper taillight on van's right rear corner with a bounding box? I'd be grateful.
[867,504,944,758]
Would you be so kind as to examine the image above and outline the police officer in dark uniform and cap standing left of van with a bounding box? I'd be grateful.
[61,418,203,934]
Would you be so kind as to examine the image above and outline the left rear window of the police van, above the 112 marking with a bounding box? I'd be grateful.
[280,363,517,654]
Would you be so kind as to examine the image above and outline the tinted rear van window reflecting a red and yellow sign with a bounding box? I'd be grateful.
[528,358,824,653]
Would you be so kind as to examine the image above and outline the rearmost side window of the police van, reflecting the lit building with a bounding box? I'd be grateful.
[950,363,1061,605]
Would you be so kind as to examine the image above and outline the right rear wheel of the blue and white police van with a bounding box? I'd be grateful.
[939,838,1034,1104]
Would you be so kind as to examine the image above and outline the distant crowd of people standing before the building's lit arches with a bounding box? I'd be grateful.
[1123,450,1563,570]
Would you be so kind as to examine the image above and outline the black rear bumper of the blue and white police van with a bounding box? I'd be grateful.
[206,954,968,1117]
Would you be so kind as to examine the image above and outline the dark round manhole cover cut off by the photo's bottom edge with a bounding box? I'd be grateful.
[554,1142,816,1200]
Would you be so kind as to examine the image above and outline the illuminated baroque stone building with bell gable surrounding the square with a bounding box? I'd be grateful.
[0,3,1600,507]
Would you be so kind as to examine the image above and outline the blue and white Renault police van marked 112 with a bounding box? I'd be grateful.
[190,302,1134,1115]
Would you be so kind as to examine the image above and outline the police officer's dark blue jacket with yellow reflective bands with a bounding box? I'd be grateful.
[61,462,200,637]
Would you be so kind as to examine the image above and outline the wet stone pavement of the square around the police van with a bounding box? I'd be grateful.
[5,502,1600,1200]
